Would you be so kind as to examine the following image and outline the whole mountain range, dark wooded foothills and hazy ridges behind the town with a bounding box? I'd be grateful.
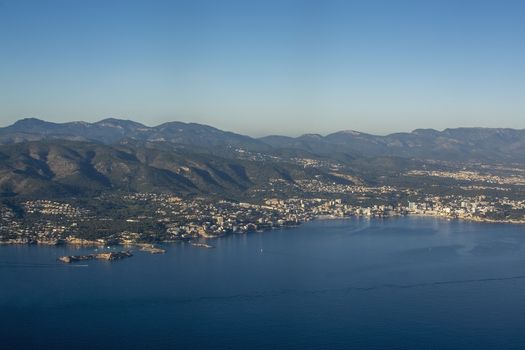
[0,118,525,197]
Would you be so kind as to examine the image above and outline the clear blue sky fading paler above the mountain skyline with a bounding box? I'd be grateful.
[0,0,525,136]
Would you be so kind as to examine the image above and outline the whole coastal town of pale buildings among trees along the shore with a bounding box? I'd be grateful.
[0,172,525,246]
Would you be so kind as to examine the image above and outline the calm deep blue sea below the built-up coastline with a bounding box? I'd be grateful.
[0,218,525,349]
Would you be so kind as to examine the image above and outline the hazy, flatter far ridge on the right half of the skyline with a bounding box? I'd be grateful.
[260,128,525,163]
